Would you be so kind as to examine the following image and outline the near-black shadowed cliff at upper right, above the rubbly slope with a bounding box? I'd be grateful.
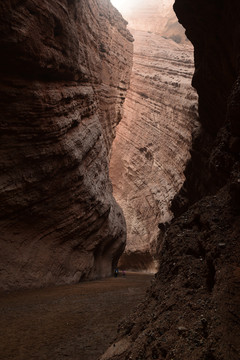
[173,0,240,213]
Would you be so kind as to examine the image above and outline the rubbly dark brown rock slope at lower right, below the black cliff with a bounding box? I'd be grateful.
[101,189,240,360]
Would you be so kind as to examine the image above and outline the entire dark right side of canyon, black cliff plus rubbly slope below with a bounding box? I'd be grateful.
[103,0,240,360]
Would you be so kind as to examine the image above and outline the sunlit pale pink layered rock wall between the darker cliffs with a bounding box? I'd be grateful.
[110,31,197,270]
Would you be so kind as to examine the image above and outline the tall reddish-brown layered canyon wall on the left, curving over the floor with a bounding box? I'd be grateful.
[0,0,132,289]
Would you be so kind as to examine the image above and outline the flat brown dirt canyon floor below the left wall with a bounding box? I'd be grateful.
[0,273,153,360]
